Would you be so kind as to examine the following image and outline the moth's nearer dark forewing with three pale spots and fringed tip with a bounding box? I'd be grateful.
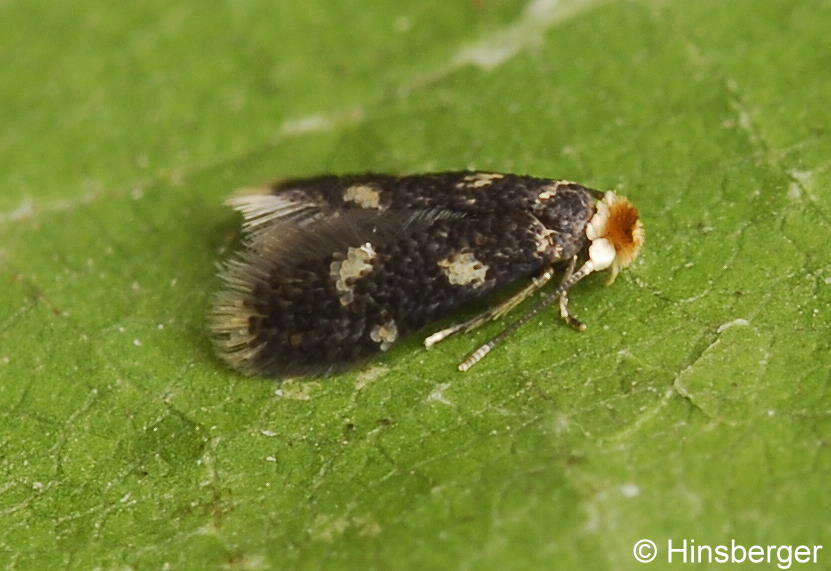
[212,208,552,376]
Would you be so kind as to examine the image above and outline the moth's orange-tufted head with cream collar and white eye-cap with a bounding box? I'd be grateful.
[586,191,644,283]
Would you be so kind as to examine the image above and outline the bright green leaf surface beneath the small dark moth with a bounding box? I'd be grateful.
[0,0,831,569]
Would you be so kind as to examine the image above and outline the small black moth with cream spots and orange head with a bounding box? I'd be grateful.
[210,171,644,376]
